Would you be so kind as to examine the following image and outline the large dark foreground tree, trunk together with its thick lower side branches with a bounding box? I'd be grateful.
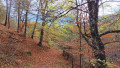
[78,0,120,68]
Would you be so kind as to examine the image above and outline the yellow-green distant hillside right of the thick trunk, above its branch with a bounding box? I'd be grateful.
[98,11,120,33]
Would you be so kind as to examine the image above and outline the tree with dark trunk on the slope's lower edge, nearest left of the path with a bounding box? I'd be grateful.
[38,0,60,46]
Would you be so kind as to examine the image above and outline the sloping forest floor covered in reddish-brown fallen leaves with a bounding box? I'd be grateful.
[0,25,71,68]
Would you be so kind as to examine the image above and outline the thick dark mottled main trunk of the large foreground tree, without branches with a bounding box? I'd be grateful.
[88,0,106,68]
